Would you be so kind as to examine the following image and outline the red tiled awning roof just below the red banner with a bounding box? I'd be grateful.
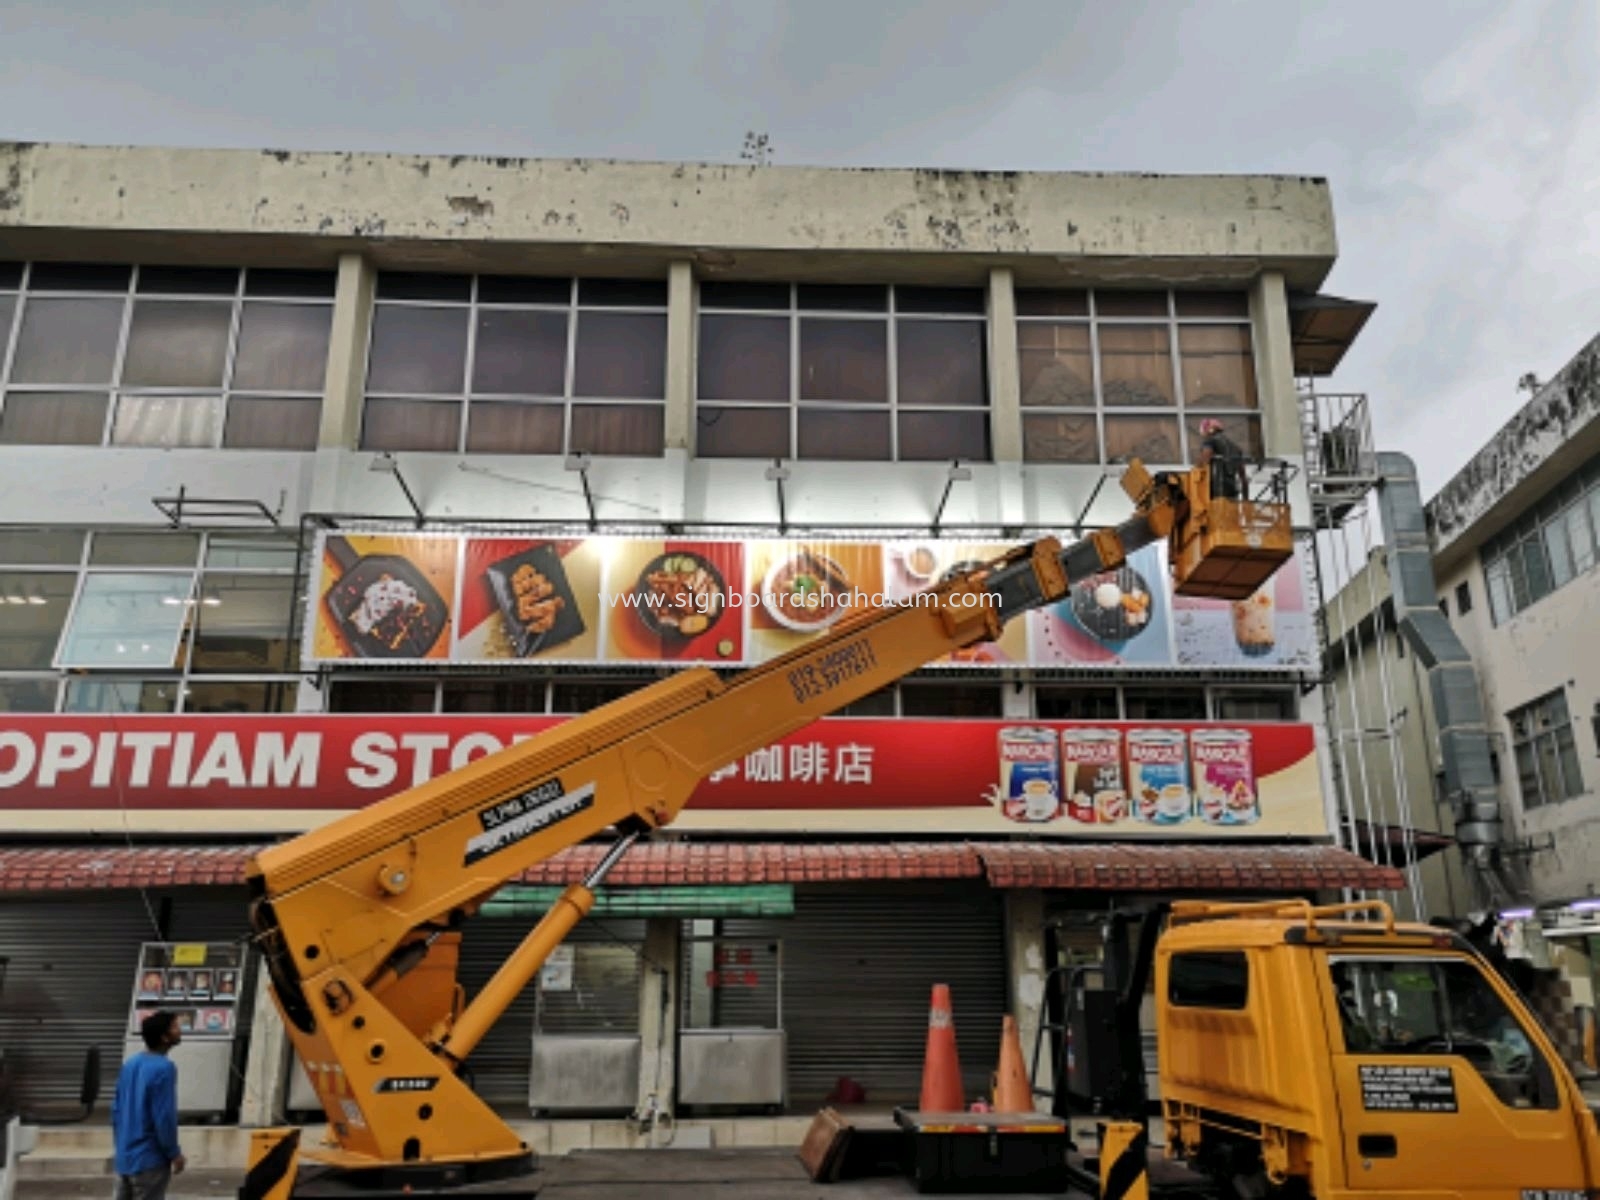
[0,842,1405,896]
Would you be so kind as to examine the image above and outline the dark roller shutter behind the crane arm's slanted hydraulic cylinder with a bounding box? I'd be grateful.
[458,917,645,1107]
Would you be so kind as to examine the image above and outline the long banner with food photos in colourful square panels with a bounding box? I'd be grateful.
[302,533,1315,669]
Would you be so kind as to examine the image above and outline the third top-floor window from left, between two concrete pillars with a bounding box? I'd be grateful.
[694,283,990,462]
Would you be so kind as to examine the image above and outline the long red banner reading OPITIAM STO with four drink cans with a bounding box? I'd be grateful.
[0,714,1326,837]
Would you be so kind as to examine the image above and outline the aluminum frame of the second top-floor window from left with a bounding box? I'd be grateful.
[357,272,672,458]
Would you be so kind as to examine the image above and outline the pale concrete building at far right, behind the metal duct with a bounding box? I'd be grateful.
[1326,339,1600,1066]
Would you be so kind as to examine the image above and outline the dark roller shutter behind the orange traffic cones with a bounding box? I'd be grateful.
[710,882,1006,1112]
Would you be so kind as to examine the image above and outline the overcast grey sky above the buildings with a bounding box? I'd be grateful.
[0,0,1600,494]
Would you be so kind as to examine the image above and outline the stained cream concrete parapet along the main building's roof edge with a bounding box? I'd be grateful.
[0,142,1336,288]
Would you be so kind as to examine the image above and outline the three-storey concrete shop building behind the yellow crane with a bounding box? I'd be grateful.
[0,144,1402,1149]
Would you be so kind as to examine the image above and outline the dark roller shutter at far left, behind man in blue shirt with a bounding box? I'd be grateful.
[0,891,160,1114]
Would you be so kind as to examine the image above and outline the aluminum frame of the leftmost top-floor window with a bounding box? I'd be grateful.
[0,261,334,453]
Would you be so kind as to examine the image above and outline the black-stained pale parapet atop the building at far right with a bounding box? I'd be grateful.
[1427,336,1600,565]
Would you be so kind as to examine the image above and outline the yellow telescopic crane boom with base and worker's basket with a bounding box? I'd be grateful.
[240,461,1594,1200]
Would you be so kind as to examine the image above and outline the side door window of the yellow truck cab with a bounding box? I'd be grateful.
[1330,958,1547,1107]
